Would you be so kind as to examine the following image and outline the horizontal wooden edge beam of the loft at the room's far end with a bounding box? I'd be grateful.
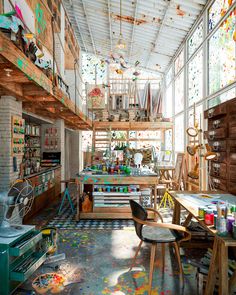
[93,122,173,131]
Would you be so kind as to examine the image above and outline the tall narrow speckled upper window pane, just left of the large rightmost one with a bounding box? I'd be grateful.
[188,49,203,105]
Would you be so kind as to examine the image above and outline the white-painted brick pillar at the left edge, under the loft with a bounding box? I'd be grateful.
[0,96,22,191]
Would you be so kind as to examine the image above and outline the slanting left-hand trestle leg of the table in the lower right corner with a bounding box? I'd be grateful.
[204,236,219,295]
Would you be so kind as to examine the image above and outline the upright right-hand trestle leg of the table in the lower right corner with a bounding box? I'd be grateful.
[219,241,229,295]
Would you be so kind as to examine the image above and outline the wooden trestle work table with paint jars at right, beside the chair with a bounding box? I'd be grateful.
[170,191,236,295]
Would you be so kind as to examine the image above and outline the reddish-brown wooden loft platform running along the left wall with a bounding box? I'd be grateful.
[0,32,92,130]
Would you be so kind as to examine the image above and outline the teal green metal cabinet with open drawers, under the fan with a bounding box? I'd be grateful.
[0,225,46,295]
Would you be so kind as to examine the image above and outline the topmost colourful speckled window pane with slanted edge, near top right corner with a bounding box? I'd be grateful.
[208,0,235,31]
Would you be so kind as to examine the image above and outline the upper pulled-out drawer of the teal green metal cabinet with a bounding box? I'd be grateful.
[9,231,42,256]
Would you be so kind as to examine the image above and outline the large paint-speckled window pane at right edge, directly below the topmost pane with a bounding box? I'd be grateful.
[209,13,236,94]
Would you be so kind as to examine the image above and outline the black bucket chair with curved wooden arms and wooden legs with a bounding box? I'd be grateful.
[129,200,191,295]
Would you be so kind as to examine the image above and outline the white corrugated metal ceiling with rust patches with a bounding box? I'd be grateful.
[63,0,207,72]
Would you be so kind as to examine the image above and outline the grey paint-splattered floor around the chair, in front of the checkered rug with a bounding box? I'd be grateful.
[16,228,203,295]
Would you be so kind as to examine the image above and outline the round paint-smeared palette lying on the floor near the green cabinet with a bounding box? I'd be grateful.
[32,273,65,294]
